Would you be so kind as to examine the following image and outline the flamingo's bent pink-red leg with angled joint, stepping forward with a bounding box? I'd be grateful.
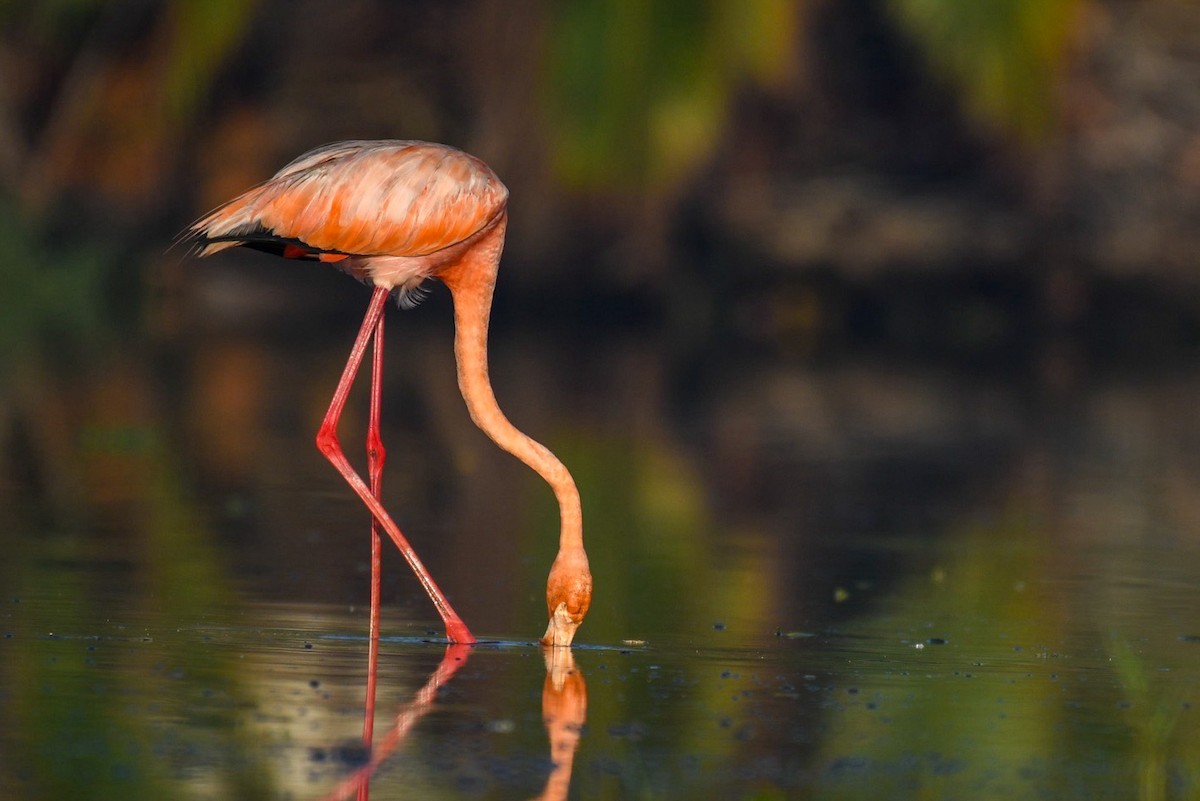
[317,287,475,643]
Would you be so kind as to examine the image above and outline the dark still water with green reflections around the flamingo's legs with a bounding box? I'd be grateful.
[0,266,1200,800]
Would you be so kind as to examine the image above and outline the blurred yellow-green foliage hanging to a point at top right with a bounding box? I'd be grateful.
[888,0,1084,140]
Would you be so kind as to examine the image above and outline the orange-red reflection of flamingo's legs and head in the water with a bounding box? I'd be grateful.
[322,640,588,801]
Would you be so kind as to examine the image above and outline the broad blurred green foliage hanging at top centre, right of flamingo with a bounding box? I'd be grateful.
[546,0,798,188]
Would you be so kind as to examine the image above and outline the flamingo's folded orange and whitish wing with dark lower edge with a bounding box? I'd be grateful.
[188,140,508,260]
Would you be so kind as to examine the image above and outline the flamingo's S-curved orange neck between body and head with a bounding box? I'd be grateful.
[440,236,583,550]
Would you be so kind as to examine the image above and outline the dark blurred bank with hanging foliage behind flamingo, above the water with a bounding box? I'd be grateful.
[7,0,1200,362]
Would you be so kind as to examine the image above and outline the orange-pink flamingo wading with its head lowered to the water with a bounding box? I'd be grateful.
[184,140,592,646]
